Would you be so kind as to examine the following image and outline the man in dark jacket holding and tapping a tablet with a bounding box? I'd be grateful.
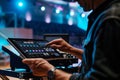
[23,0,120,80]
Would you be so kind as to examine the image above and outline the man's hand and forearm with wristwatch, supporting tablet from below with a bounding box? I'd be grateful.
[23,58,72,80]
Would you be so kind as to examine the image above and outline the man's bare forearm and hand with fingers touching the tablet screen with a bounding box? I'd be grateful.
[47,38,83,59]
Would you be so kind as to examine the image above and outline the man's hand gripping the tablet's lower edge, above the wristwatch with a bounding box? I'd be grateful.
[23,58,54,76]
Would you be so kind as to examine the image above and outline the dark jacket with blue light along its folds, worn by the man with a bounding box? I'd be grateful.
[70,0,120,80]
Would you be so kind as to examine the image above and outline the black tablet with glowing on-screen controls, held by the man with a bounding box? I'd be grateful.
[8,38,63,59]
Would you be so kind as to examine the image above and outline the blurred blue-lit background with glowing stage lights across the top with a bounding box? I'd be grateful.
[0,0,89,29]
